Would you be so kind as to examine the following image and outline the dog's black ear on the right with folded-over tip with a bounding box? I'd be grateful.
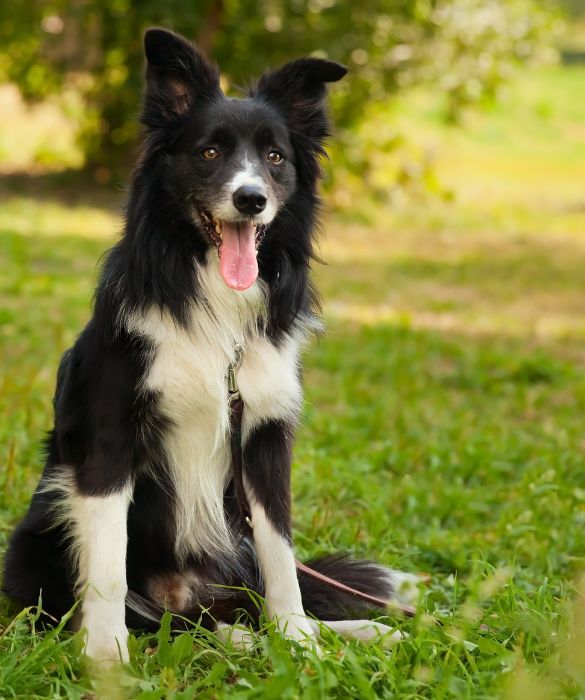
[254,58,347,140]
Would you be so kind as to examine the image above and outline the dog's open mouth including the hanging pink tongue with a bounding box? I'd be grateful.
[199,209,266,292]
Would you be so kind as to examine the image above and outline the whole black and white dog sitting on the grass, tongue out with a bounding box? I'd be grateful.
[4,29,406,660]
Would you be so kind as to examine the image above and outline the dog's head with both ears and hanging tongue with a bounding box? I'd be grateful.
[142,29,347,291]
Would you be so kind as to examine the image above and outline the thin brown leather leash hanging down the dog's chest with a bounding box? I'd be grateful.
[226,345,416,617]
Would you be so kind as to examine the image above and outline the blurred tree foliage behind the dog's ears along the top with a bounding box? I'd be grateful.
[0,0,552,186]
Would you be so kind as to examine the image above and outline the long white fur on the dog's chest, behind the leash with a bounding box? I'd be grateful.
[127,253,301,557]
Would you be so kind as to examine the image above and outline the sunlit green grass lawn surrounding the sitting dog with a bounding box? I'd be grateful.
[0,63,585,700]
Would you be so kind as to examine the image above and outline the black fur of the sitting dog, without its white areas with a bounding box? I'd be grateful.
[3,30,396,627]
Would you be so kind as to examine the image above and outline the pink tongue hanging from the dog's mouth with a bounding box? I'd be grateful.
[219,221,258,292]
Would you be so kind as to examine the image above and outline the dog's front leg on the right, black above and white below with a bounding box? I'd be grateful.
[244,420,315,640]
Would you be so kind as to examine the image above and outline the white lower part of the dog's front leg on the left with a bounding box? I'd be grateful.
[72,486,132,662]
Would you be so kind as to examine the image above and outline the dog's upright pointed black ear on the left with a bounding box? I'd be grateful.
[142,29,220,126]
